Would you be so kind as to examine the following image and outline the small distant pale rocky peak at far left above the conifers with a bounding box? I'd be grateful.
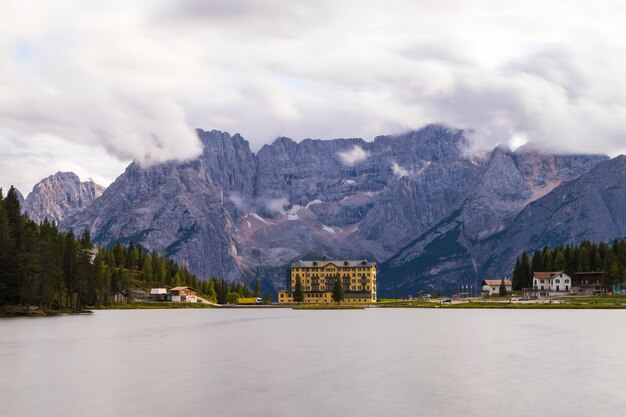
[22,172,104,223]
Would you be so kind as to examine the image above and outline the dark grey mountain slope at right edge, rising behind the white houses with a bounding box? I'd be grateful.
[477,155,626,274]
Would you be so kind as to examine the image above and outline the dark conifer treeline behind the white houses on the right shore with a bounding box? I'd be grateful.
[512,239,626,290]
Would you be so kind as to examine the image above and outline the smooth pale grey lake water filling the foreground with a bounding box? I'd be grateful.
[0,309,626,417]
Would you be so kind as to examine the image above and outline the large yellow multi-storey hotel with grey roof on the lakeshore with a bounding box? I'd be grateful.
[278,260,376,304]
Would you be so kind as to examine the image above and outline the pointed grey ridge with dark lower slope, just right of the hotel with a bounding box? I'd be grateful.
[379,148,607,295]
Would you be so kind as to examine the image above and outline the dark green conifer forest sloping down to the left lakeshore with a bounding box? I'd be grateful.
[0,187,261,310]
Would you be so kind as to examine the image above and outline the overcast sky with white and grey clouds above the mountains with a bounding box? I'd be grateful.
[0,0,626,194]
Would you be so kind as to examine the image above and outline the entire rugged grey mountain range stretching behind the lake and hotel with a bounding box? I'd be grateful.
[17,125,626,296]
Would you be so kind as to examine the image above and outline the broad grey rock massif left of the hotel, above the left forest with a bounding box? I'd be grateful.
[61,131,254,279]
